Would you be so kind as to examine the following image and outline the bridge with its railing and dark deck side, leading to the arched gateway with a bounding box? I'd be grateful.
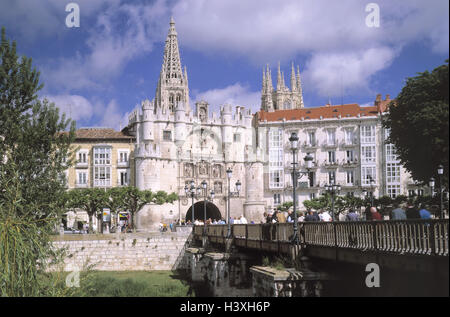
[193,219,449,278]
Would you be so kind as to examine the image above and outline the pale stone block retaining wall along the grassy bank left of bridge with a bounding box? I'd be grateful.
[51,232,190,271]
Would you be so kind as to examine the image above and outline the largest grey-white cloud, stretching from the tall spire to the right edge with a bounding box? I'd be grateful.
[173,0,449,96]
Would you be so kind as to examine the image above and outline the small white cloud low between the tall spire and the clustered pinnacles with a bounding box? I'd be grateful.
[195,83,261,111]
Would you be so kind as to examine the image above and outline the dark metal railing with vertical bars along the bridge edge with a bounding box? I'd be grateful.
[194,219,449,256]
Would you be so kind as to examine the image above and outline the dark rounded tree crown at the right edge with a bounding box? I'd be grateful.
[383,60,449,184]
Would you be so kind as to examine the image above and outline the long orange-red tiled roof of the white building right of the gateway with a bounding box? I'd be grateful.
[258,101,389,121]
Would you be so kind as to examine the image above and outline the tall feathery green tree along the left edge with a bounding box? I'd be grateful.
[0,28,75,296]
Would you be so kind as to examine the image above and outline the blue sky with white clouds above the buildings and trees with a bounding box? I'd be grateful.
[0,0,449,129]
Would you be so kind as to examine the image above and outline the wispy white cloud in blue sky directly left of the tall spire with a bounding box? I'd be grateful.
[41,0,168,91]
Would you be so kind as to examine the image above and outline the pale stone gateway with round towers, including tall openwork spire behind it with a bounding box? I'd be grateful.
[127,20,265,228]
